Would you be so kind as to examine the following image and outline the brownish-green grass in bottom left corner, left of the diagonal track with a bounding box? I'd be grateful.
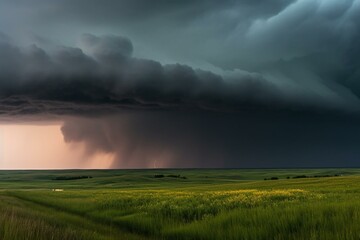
[0,194,143,240]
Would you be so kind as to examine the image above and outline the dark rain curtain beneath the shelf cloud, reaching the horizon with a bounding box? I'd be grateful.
[62,111,360,168]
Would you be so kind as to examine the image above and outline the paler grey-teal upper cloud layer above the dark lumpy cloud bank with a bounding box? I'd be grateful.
[0,0,360,69]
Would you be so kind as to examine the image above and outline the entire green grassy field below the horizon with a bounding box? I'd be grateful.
[0,169,360,240]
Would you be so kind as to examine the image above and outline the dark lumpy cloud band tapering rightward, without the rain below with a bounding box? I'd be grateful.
[0,34,332,115]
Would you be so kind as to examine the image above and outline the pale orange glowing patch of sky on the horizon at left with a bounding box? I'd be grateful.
[0,123,113,169]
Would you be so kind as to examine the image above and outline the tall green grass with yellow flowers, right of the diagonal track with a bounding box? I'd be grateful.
[6,189,354,239]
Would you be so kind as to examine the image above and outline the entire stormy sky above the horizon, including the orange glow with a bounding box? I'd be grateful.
[0,0,360,169]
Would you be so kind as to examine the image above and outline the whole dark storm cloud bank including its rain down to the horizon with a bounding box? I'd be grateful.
[0,34,360,167]
